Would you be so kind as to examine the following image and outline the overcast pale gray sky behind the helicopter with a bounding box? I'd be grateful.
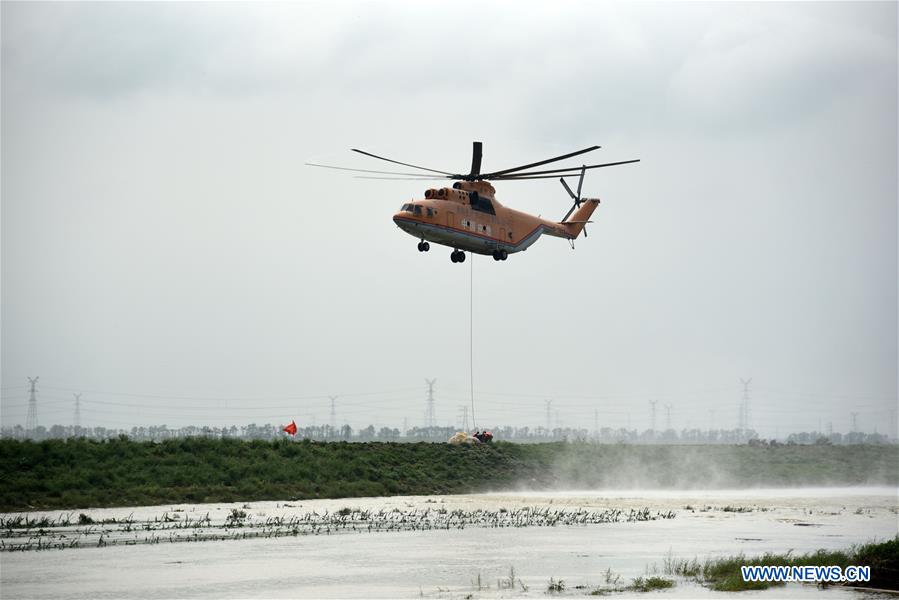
[0,2,897,436]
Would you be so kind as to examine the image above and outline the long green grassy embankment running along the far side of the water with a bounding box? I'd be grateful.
[0,438,899,511]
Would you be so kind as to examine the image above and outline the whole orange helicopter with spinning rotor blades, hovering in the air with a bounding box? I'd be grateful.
[306,142,640,263]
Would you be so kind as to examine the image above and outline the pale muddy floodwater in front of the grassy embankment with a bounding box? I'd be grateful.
[0,487,899,599]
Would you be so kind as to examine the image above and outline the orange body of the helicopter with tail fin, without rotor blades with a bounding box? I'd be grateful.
[393,181,599,257]
